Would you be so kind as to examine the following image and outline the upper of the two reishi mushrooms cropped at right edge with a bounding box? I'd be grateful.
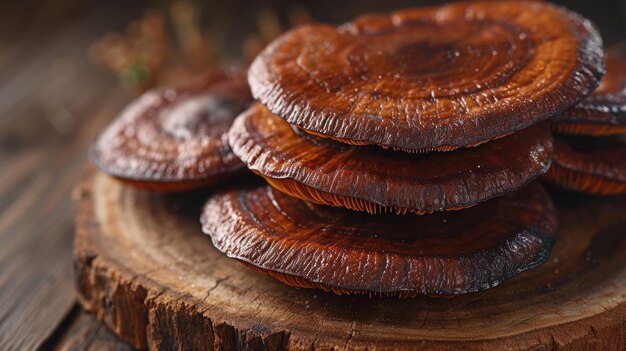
[552,57,626,135]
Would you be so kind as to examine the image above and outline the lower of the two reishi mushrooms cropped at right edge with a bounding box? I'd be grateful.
[545,137,626,195]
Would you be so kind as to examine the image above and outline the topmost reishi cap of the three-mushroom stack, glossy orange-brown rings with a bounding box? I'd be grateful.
[248,1,604,150]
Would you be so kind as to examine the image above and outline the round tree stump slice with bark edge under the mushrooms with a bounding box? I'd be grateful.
[75,171,626,350]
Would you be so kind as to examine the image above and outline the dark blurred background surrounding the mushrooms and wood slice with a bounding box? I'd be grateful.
[0,0,626,350]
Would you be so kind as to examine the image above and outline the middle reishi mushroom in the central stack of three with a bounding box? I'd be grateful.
[229,103,552,214]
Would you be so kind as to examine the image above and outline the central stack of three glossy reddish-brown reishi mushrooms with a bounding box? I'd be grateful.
[202,2,604,297]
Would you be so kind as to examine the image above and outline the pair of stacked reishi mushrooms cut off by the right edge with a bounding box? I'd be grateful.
[546,56,626,195]
